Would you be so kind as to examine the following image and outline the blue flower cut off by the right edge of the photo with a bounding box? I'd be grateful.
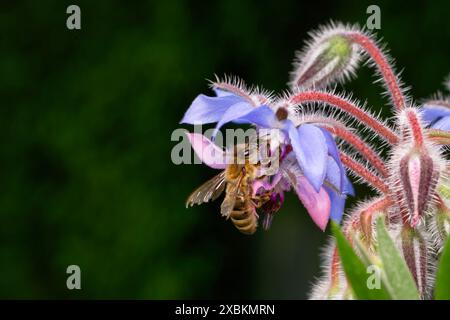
[421,101,450,131]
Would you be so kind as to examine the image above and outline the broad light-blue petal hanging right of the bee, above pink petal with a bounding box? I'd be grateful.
[287,120,328,192]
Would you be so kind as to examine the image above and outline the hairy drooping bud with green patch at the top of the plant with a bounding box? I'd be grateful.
[290,26,359,89]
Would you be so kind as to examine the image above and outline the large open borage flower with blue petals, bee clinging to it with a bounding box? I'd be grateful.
[181,88,354,230]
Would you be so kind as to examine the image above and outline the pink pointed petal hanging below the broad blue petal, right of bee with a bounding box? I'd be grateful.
[295,176,331,231]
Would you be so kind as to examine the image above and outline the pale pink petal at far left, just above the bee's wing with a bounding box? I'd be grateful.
[187,133,227,169]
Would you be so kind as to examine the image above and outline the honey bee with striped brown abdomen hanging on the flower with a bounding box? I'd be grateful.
[186,145,269,234]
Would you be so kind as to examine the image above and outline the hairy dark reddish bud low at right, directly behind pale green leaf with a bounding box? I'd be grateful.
[400,226,432,298]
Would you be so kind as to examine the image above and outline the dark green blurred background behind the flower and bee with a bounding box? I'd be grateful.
[0,0,450,299]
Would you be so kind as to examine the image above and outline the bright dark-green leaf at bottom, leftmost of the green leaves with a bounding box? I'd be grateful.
[331,222,390,300]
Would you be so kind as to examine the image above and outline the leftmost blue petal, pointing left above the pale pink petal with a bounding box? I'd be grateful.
[180,94,245,124]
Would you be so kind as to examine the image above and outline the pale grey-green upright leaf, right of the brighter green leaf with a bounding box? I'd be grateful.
[377,217,420,300]
